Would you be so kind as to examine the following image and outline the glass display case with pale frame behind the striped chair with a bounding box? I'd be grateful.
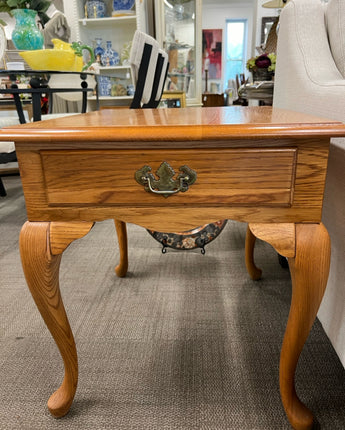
[155,0,202,106]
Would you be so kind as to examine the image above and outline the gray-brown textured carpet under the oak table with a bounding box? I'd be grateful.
[0,177,345,430]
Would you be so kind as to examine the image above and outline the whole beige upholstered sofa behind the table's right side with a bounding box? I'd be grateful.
[273,0,345,367]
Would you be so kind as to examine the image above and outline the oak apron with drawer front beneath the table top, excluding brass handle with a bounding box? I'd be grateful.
[17,141,328,227]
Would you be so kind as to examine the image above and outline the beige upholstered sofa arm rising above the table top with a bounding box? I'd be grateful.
[273,0,345,121]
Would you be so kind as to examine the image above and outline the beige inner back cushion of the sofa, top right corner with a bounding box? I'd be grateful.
[326,0,345,78]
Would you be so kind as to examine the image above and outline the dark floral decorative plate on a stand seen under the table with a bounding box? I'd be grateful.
[147,219,227,252]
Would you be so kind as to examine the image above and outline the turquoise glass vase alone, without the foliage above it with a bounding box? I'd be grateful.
[12,9,44,50]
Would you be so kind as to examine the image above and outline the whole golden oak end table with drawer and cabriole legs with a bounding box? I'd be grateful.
[1,107,345,429]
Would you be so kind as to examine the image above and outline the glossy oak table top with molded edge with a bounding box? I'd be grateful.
[1,106,345,143]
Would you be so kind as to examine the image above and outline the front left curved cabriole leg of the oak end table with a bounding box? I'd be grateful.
[20,222,93,417]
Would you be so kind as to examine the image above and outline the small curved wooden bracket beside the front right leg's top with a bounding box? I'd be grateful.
[248,223,296,257]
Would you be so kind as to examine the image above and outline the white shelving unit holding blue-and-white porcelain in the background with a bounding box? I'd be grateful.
[64,0,146,108]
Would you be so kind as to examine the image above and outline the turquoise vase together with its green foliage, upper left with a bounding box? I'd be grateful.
[0,0,51,50]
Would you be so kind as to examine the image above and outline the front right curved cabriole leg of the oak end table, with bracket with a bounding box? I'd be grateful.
[250,224,331,430]
